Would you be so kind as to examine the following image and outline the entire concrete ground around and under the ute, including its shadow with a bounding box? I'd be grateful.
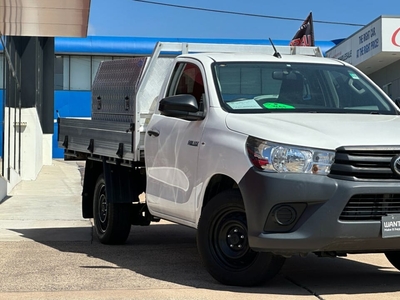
[0,160,400,300]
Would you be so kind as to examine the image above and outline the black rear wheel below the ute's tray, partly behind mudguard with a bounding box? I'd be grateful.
[93,174,131,244]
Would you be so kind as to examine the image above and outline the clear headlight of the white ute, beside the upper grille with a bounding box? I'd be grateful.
[246,137,335,175]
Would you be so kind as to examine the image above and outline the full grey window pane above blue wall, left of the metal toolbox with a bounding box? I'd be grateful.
[70,56,92,91]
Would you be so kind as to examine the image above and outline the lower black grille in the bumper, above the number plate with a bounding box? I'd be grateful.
[339,194,400,221]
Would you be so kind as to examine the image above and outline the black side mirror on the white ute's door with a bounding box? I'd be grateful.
[158,94,205,121]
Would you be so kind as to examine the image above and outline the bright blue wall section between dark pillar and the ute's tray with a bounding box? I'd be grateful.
[53,91,92,158]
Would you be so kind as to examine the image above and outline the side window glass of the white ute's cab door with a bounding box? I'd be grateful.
[167,63,204,110]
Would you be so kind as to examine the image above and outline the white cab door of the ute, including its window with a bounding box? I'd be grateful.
[145,61,207,224]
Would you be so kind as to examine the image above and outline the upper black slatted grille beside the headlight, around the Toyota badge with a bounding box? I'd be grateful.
[329,147,400,181]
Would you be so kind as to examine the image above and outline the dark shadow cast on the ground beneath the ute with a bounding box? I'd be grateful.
[10,223,400,295]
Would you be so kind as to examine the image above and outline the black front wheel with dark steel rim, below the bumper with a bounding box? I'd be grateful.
[197,190,285,286]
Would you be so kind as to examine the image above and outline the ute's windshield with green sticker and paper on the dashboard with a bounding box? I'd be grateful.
[213,62,397,114]
